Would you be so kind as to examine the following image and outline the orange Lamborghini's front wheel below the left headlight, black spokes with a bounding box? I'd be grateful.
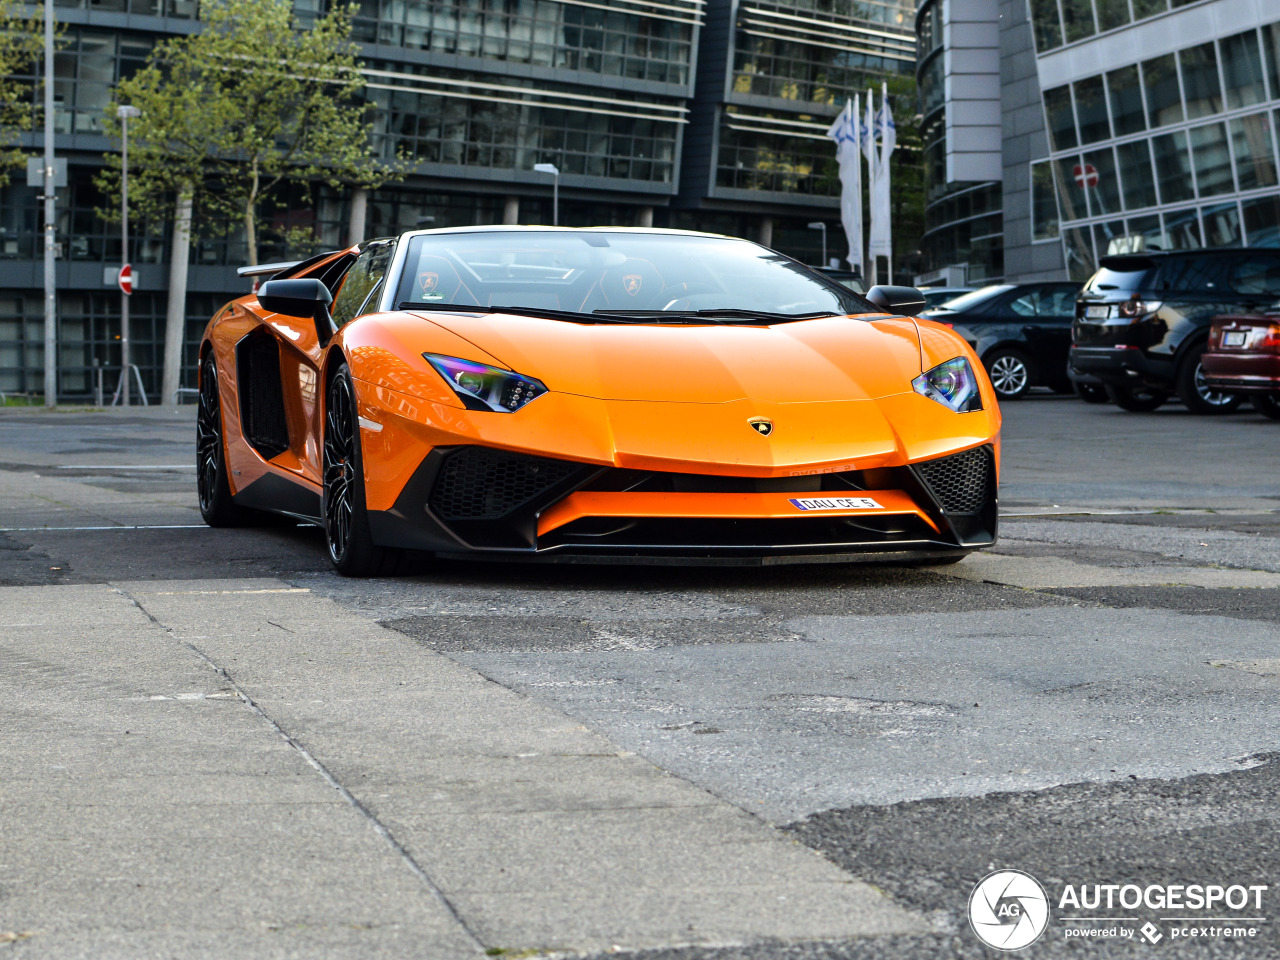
[323,364,402,577]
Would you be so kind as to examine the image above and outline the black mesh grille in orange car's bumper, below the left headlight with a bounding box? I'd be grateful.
[430,447,582,520]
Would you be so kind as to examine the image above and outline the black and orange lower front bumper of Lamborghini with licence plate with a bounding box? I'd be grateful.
[370,444,997,564]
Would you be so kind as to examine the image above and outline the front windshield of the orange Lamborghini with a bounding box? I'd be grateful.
[397,230,882,321]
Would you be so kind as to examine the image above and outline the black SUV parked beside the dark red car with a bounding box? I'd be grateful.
[1070,248,1280,413]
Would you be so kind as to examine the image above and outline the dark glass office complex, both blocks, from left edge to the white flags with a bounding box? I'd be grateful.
[0,0,914,402]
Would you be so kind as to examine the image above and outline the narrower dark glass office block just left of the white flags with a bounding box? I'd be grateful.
[672,0,915,262]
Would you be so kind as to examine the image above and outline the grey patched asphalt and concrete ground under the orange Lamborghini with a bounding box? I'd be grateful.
[0,396,1280,960]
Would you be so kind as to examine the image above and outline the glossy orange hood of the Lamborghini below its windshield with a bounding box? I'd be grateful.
[416,314,920,403]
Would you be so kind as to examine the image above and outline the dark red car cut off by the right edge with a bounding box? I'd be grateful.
[1201,312,1280,420]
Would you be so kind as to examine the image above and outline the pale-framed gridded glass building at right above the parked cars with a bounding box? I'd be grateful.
[918,0,1280,282]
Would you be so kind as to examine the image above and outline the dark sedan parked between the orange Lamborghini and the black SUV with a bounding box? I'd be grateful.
[925,283,1080,401]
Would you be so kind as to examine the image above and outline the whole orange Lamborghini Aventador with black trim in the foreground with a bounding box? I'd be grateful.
[196,227,1000,576]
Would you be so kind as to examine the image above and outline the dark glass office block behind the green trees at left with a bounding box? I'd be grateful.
[0,0,703,402]
